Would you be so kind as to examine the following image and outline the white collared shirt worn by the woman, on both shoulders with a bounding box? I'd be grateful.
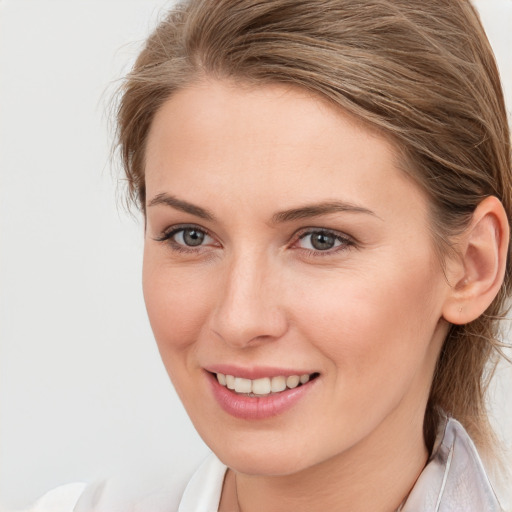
[30,418,502,512]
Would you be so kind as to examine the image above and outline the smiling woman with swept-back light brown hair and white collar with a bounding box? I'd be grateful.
[34,0,512,512]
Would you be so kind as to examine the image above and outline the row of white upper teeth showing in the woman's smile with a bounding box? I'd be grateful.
[217,373,310,396]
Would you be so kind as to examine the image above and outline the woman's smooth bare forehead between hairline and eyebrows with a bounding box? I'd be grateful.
[146,81,424,222]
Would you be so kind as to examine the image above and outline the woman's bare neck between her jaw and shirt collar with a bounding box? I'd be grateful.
[219,404,428,512]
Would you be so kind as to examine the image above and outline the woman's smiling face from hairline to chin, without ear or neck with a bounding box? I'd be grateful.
[143,81,450,474]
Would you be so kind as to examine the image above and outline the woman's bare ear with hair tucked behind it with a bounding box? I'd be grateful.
[443,196,510,325]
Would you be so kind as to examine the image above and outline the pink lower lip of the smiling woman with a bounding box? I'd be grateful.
[207,373,318,420]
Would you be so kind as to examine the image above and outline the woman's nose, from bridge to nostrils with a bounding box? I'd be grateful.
[211,255,288,348]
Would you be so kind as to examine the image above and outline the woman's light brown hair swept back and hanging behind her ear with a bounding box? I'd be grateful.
[117,0,512,454]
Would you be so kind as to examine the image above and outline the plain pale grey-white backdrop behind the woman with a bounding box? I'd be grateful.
[0,0,512,509]
